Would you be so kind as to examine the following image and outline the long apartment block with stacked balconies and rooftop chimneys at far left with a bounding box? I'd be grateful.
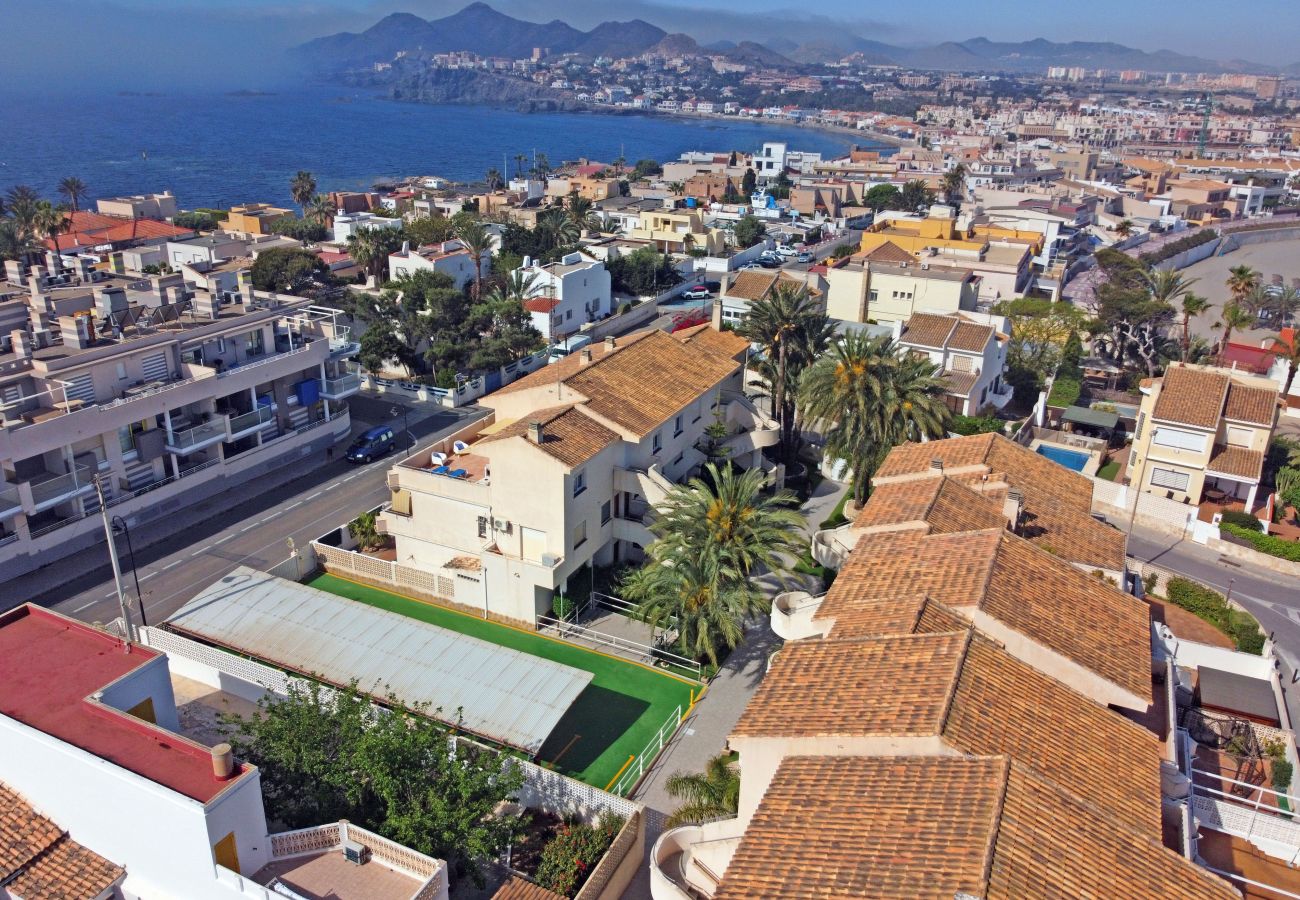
[0,273,360,572]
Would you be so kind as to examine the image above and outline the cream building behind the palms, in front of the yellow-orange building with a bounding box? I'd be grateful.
[826,242,979,324]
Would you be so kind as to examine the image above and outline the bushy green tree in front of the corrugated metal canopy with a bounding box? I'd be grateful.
[224,682,524,886]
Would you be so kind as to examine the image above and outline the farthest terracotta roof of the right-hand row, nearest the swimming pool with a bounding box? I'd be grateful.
[876,434,1125,571]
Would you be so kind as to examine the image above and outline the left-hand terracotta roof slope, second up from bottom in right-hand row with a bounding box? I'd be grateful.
[732,633,967,737]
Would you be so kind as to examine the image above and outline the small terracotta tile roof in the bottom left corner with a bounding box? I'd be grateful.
[0,784,125,900]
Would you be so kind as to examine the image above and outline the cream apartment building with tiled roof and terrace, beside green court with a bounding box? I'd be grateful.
[378,325,779,627]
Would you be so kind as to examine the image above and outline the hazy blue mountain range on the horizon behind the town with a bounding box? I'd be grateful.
[294,3,1300,73]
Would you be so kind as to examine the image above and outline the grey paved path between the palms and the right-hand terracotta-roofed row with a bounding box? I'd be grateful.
[623,479,845,900]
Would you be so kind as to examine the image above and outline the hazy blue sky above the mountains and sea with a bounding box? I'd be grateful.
[0,0,1300,94]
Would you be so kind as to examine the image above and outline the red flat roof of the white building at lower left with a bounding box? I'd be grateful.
[0,603,251,802]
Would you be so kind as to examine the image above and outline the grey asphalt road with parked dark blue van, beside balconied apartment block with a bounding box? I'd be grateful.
[0,394,488,632]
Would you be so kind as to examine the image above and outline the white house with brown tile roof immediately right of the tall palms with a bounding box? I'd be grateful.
[898,312,1011,416]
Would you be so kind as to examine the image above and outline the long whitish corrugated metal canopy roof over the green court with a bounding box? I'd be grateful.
[166,566,592,753]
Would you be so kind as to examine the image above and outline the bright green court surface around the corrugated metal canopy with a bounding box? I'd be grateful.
[307,575,701,789]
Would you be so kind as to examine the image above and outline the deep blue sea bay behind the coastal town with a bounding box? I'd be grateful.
[0,86,892,208]
